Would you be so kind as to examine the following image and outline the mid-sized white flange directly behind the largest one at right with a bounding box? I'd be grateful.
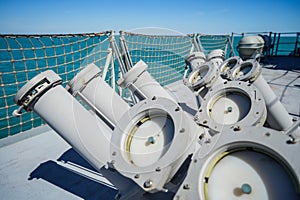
[195,81,267,133]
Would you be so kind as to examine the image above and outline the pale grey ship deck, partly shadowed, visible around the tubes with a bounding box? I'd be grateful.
[0,56,300,200]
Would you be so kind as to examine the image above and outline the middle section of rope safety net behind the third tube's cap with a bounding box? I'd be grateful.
[119,32,192,86]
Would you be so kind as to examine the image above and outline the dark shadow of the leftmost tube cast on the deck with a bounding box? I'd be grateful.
[28,149,118,200]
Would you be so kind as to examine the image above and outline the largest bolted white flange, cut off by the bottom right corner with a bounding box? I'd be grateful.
[174,127,300,200]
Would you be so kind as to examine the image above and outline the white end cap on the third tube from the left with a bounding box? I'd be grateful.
[117,60,148,88]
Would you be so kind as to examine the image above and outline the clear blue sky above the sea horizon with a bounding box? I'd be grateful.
[0,0,300,34]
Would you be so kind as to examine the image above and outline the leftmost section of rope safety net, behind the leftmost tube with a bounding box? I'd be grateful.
[0,32,111,138]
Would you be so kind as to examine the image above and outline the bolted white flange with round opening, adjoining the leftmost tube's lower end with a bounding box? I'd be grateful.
[110,98,203,192]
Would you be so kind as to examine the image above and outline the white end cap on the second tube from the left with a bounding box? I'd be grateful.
[68,63,101,96]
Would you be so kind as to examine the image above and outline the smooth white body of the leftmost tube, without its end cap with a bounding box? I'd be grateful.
[33,85,112,170]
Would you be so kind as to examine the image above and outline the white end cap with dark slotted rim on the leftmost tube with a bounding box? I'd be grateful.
[14,70,62,111]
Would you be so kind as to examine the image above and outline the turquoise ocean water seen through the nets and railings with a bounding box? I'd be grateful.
[0,35,296,138]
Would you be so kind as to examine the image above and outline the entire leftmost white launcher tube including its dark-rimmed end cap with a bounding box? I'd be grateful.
[15,70,112,170]
